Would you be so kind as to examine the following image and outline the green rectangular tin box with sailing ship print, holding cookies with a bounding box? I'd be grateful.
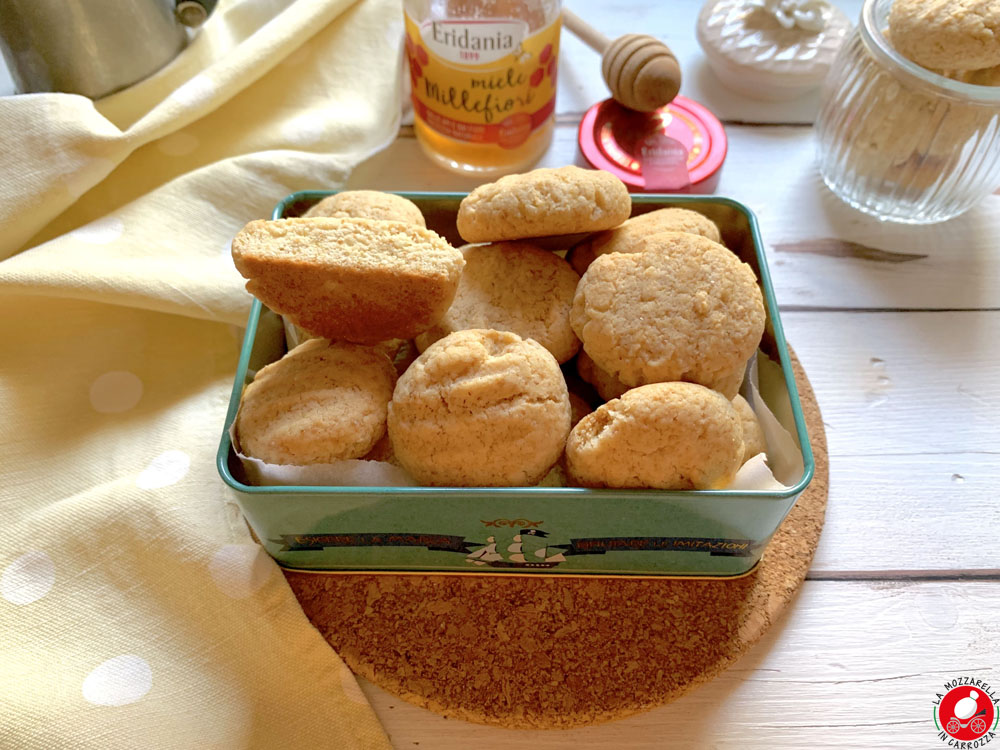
[218,191,814,577]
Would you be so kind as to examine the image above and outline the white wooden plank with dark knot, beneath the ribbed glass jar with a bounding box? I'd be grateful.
[348,121,1000,309]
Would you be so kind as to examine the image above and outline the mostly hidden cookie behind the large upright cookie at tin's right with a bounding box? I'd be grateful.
[566,208,722,276]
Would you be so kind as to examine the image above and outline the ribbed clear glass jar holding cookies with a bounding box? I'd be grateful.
[816,0,1000,224]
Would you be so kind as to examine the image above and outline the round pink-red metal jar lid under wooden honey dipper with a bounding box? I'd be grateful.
[578,96,727,193]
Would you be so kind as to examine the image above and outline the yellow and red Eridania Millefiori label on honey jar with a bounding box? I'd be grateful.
[406,15,560,149]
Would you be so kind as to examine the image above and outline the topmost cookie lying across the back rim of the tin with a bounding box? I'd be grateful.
[457,166,632,242]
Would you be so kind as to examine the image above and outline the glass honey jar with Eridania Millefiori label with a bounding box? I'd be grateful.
[404,0,561,177]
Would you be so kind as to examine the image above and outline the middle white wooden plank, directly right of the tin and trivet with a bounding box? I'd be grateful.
[782,312,1000,576]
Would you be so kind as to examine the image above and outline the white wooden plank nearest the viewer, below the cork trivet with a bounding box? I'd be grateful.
[363,581,1000,750]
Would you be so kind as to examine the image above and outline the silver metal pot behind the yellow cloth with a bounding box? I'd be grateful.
[0,0,216,99]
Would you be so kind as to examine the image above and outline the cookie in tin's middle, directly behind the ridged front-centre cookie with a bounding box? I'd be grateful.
[416,242,580,363]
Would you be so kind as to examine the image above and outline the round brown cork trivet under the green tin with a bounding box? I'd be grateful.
[285,357,828,729]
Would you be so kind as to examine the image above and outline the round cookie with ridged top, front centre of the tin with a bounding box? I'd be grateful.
[388,329,570,487]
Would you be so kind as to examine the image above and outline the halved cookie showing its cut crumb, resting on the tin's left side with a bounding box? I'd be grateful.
[233,218,465,344]
